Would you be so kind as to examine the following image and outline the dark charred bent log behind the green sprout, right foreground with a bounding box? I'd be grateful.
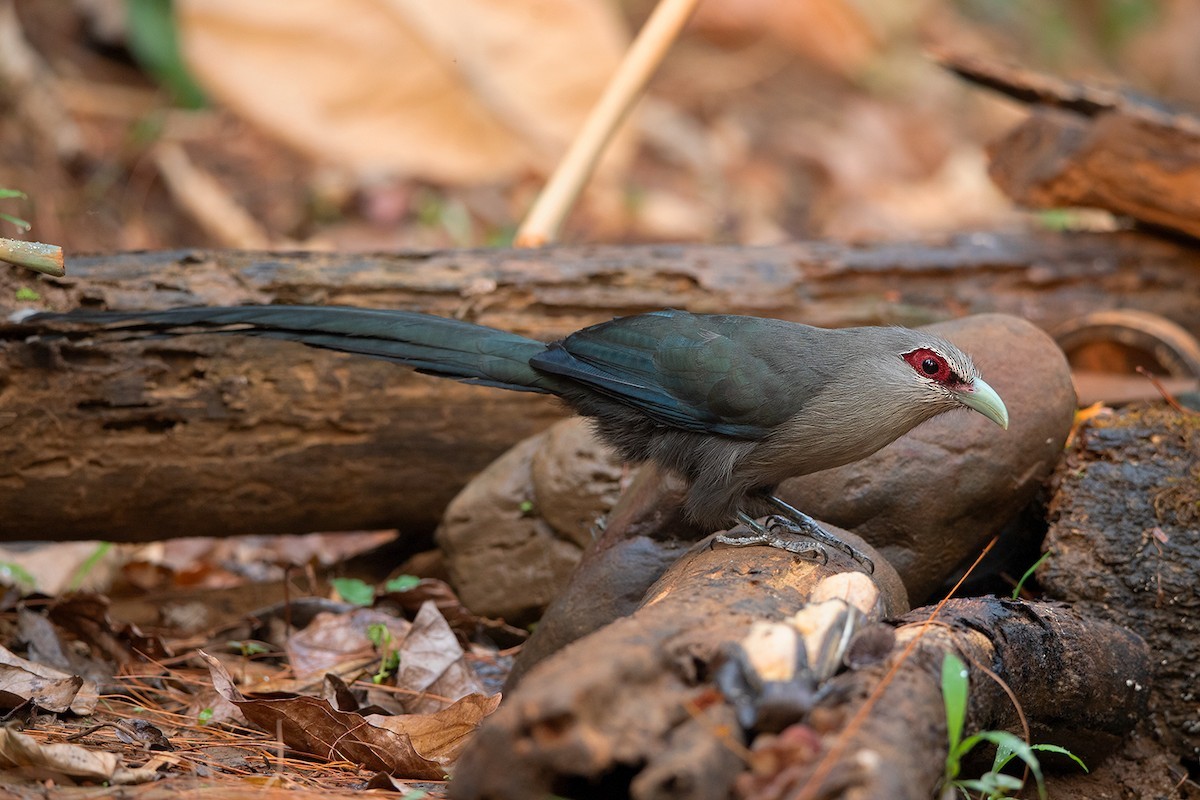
[739,597,1151,800]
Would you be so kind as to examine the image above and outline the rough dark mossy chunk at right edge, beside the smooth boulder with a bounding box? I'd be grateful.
[1038,404,1200,762]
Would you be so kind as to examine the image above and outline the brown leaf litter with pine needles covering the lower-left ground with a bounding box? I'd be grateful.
[0,579,511,796]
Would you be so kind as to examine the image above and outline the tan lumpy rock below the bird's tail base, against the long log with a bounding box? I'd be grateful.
[437,419,622,625]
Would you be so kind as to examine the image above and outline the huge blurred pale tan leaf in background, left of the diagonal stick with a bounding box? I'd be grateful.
[176,0,629,184]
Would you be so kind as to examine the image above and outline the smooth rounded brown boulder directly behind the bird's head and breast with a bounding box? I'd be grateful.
[780,314,1075,604]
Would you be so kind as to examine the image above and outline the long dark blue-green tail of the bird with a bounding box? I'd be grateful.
[20,306,554,392]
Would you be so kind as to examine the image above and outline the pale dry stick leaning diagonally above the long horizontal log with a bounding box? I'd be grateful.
[512,0,700,247]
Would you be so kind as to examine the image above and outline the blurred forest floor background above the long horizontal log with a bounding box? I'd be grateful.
[0,0,1185,254]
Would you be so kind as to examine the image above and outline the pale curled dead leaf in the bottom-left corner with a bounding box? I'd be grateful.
[0,728,166,784]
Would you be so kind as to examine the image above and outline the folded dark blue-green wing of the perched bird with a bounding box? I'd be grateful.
[529,311,803,439]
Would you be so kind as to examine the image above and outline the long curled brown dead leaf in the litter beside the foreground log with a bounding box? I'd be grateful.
[199,651,499,781]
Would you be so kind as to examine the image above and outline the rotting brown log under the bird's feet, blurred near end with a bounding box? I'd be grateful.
[450,531,906,800]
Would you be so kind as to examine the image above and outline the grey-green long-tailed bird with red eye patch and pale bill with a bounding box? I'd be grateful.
[20,305,1008,564]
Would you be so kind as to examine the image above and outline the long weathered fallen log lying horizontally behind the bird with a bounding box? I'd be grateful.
[0,234,1200,541]
